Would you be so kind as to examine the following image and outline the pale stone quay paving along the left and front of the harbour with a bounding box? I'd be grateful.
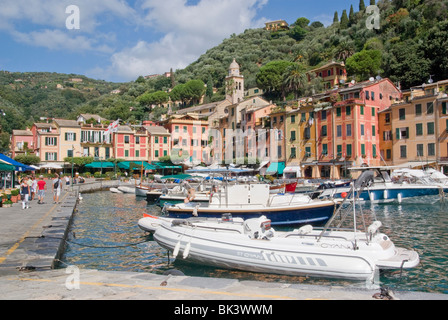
[0,183,448,305]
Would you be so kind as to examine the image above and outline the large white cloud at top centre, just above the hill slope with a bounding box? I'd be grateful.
[92,0,267,80]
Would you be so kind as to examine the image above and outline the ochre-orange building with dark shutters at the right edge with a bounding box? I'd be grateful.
[391,81,448,169]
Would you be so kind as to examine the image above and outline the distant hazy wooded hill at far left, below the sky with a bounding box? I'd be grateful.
[0,71,121,129]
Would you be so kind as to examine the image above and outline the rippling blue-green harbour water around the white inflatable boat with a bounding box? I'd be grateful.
[63,191,448,294]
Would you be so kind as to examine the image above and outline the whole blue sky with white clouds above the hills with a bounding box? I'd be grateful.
[0,0,360,82]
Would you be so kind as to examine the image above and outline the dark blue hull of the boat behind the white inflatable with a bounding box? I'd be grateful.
[166,201,335,226]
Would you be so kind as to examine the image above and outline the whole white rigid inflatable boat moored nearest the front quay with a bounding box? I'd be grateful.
[154,212,419,282]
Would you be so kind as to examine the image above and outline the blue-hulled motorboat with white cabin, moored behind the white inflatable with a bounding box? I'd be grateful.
[163,184,338,226]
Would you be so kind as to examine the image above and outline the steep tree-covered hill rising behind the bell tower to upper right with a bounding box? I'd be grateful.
[176,0,448,92]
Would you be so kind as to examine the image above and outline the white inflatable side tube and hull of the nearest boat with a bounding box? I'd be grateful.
[154,224,377,281]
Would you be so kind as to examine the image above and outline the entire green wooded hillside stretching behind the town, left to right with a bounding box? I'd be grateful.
[0,0,448,139]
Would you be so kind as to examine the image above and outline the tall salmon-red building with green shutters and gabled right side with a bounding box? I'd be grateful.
[316,79,401,179]
